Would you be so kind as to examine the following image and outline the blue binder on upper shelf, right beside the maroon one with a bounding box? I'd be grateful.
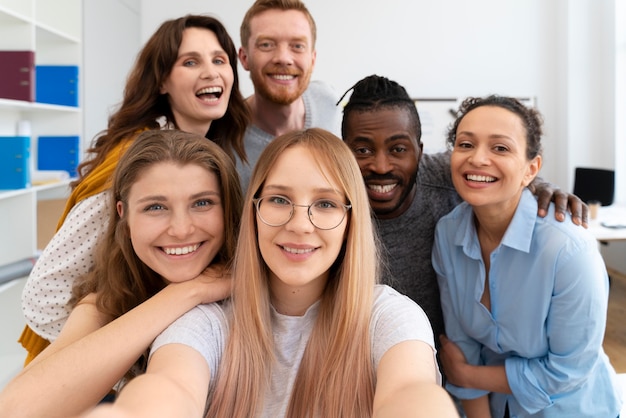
[35,65,78,106]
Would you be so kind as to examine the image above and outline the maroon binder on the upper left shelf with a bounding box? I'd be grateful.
[0,51,35,102]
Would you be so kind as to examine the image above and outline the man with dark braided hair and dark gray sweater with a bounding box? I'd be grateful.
[341,75,587,350]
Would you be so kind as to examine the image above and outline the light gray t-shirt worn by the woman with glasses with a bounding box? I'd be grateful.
[150,285,441,418]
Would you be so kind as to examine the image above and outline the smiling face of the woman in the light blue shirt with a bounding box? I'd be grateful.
[450,106,541,216]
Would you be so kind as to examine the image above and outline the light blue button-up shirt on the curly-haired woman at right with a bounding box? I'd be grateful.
[433,190,622,418]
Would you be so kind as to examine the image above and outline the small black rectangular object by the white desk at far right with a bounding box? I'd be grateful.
[574,167,615,206]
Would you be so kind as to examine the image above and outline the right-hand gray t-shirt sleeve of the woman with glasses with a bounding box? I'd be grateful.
[370,286,441,384]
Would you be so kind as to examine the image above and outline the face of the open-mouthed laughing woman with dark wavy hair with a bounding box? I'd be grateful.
[161,27,234,136]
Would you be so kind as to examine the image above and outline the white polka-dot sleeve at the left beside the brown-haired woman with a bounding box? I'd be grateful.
[22,191,109,341]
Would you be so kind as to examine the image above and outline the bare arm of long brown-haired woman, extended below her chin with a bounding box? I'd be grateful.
[0,268,230,417]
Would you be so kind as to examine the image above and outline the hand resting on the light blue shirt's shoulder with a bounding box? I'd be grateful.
[528,177,589,228]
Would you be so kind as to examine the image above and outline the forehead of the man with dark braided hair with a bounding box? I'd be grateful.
[344,106,417,143]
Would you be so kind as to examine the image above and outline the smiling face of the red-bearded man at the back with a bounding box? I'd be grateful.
[239,9,315,105]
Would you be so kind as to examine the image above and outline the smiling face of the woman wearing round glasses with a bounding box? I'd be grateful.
[256,145,349,309]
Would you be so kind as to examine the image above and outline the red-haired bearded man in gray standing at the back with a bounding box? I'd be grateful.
[237,0,341,191]
